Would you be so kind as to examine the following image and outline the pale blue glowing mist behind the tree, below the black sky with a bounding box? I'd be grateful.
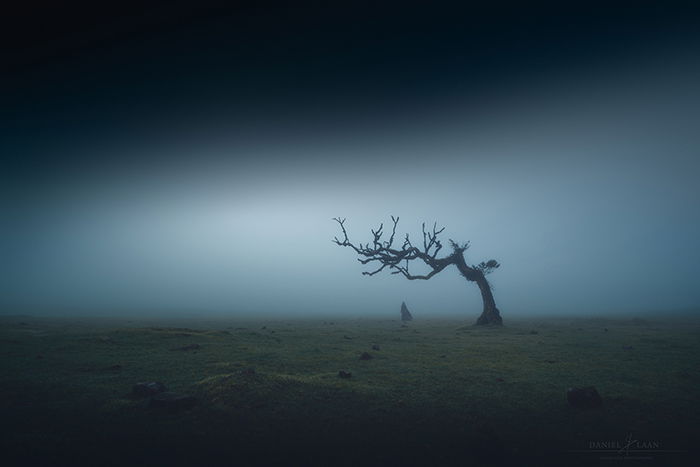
[0,69,700,317]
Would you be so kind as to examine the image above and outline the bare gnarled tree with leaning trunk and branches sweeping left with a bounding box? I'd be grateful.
[333,216,503,325]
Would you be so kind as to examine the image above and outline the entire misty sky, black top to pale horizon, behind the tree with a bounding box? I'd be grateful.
[0,1,700,316]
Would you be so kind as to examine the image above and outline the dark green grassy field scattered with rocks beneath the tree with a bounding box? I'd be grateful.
[0,316,700,466]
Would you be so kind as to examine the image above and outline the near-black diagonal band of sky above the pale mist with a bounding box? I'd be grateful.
[2,1,700,176]
